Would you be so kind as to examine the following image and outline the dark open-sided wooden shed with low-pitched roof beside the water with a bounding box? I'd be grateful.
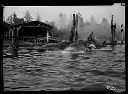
[9,21,53,42]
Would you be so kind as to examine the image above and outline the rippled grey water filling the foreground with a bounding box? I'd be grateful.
[3,45,125,92]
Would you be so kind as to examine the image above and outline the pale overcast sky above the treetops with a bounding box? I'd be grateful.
[3,3,125,25]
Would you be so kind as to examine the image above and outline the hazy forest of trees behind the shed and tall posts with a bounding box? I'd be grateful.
[3,10,125,41]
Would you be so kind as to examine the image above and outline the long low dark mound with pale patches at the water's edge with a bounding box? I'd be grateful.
[36,40,104,53]
